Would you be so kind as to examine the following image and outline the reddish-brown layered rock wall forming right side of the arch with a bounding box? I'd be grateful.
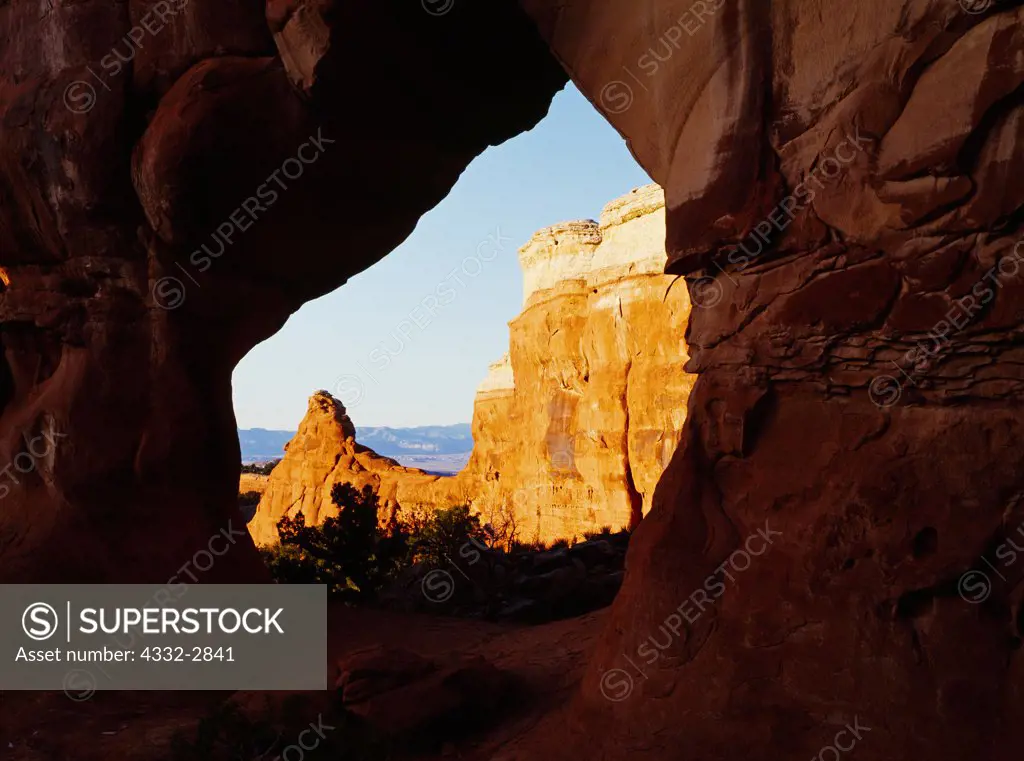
[524,0,1024,760]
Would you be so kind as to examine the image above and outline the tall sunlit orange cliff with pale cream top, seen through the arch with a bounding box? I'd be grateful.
[404,185,693,542]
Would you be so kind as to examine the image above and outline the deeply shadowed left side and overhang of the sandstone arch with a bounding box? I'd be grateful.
[0,0,565,583]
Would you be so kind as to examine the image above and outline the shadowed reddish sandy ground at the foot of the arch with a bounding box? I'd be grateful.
[0,605,604,761]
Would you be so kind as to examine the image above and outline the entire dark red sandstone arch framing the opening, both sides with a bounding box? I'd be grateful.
[0,0,1024,759]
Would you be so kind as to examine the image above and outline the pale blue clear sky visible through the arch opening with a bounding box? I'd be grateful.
[232,84,650,430]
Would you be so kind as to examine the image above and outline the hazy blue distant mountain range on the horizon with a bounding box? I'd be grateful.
[239,423,473,467]
